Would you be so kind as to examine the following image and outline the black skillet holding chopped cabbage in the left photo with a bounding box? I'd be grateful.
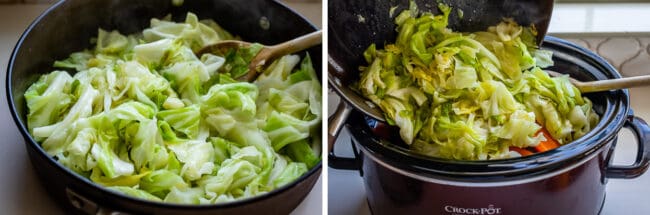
[5,0,322,214]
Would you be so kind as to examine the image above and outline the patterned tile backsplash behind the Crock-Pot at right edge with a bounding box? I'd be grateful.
[561,33,650,76]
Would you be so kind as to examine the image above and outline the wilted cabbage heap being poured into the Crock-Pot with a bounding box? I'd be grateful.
[357,4,598,160]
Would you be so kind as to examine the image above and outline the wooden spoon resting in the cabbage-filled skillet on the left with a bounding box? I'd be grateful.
[198,30,323,82]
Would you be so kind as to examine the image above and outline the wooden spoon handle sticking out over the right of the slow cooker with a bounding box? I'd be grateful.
[545,70,650,93]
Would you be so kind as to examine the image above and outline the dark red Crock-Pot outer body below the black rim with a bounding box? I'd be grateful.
[362,144,611,215]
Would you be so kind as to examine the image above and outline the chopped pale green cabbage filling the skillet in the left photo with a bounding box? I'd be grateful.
[25,13,322,204]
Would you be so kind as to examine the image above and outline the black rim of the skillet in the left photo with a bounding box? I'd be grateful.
[5,0,322,210]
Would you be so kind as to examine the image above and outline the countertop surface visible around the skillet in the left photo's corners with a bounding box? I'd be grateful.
[0,2,323,215]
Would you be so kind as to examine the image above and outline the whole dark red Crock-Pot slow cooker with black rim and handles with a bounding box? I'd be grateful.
[329,37,650,215]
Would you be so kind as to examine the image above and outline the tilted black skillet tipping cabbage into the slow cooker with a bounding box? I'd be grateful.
[327,0,553,151]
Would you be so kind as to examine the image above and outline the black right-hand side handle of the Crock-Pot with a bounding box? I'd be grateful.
[605,116,650,179]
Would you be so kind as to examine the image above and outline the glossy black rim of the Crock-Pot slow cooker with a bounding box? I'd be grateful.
[347,36,630,182]
